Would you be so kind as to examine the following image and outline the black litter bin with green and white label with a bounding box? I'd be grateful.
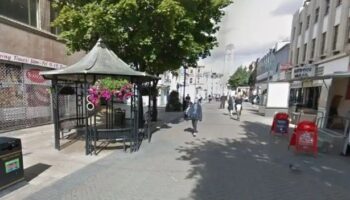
[0,137,24,190]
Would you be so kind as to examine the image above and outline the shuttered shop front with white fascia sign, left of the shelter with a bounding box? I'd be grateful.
[0,52,63,132]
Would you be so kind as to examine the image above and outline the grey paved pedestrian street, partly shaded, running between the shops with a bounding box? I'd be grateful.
[8,104,350,200]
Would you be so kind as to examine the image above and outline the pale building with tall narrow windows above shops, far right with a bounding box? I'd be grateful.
[289,0,350,119]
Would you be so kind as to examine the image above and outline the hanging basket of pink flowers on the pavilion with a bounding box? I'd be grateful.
[88,78,133,106]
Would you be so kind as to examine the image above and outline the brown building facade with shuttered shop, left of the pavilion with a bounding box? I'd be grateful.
[0,0,83,132]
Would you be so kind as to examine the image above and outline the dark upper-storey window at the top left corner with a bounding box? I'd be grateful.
[0,0,38,27]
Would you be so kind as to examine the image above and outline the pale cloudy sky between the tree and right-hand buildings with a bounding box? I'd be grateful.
[199,0,303,74]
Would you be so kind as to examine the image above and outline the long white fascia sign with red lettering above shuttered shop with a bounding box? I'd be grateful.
[0,52,65,69]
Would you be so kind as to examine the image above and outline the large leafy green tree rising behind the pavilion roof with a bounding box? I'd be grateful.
[53,0,231,120]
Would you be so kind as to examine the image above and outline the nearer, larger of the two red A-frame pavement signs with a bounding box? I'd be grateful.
[289,121,317,156]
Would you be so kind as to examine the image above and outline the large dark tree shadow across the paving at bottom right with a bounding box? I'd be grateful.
[177,121,350,200]
